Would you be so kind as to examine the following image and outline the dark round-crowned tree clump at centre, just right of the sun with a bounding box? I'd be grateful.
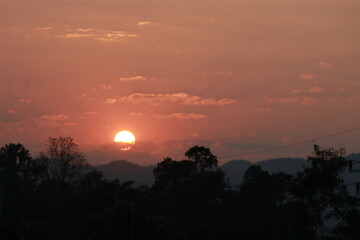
[153,146,226,201]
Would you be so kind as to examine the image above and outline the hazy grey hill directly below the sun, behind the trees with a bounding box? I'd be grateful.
[95,160,155,186]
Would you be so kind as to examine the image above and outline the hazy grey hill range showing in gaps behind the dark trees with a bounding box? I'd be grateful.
[96,153,360,188]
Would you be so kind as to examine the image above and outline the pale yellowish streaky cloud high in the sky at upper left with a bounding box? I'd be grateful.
[58,27,137,42]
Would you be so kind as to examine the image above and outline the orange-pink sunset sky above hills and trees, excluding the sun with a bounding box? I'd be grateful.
[0,0,360,165]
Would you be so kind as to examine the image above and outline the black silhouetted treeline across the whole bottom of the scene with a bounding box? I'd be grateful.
[0,137,360,240]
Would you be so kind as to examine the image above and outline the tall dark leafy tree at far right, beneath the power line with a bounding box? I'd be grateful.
[293,145,352,231]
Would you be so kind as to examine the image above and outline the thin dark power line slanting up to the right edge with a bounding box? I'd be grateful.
[220,127,360,158]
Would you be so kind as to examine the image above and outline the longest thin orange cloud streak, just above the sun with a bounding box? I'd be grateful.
[113,93,237,106]
